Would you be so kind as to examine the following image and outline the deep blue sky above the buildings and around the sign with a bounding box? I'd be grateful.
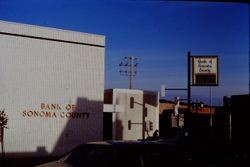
[0,0,250,105]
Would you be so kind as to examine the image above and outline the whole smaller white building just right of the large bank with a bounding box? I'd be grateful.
[104,89,159,140]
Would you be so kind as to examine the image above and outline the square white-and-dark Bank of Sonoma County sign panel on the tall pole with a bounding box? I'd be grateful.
[192,56,218,86]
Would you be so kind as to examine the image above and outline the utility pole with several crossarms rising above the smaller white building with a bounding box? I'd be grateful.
[119,56,138,89]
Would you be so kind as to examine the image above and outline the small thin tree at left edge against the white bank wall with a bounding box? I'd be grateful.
[0,109,8,158]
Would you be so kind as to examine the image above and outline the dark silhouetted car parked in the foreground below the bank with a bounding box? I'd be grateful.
[37,141,192,167]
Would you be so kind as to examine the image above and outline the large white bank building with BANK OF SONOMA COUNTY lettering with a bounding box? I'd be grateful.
[0,21,105,157]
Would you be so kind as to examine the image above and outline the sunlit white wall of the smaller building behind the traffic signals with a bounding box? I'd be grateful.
[105,89,159,140]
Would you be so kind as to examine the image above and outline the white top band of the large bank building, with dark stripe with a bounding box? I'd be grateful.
[0,21,105,47]
